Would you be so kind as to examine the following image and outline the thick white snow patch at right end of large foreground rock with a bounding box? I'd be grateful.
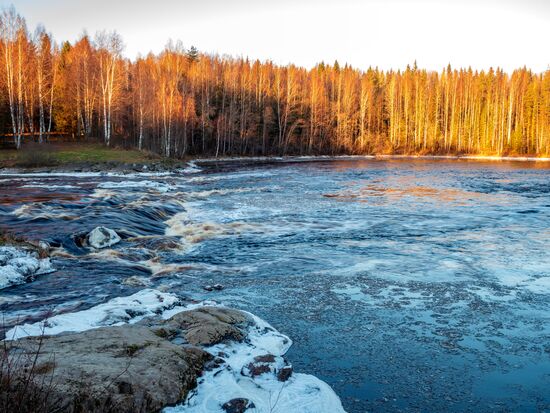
[163,313,344,413]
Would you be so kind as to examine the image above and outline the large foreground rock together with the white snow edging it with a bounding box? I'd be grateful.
[0,290,343,413]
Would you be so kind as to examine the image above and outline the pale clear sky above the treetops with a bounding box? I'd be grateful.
[4,0,550,72]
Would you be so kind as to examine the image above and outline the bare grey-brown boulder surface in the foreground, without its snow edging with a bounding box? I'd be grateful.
[0,307,251,413]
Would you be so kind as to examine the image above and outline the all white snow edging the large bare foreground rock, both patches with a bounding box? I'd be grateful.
[6,289,344,413]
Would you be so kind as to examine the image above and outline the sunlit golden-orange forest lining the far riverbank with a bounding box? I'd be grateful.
[0,7,550,157]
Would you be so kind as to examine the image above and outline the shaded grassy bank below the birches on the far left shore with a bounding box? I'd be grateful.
[0,143,161,168]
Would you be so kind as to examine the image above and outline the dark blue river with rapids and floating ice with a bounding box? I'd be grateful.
[0,160,550,412]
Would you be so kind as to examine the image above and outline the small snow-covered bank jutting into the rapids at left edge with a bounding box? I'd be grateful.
[0,247,54,289]
